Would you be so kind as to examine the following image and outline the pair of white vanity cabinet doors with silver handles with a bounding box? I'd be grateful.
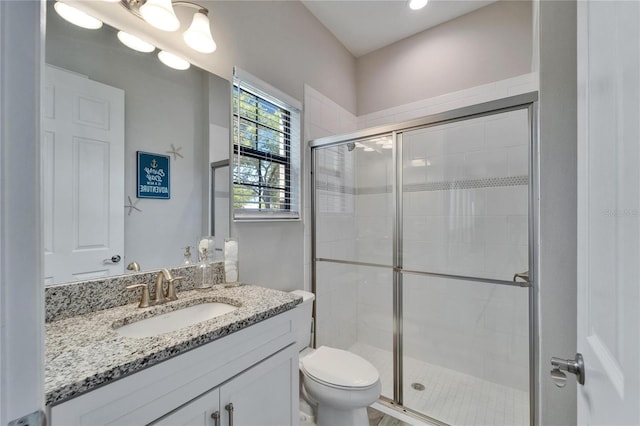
[152,350,299,426]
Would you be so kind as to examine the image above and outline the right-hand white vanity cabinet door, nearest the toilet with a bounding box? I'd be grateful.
[220,345,300,426]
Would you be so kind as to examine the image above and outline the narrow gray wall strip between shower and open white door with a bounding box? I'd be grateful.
[538,1,577,425]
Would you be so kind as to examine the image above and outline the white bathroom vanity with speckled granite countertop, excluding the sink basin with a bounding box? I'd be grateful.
[46,286,301,426]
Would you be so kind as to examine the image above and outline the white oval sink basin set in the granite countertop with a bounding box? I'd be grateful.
[116,302,238,338]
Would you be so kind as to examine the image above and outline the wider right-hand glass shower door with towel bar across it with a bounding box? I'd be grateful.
[398,109,530,426]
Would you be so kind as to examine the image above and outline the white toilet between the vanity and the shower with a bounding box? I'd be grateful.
[292,290,381,426]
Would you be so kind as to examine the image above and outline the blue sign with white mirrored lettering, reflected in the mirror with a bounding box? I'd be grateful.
[138,151,171,199]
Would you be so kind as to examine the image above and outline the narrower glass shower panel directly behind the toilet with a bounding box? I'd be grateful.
[314,135,394,399]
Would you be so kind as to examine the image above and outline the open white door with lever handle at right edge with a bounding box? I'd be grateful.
[576,1,640,425]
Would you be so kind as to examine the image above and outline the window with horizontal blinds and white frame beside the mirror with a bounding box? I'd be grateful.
[233,69,300,220]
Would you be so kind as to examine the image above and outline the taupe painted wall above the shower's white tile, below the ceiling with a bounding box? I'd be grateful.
[356,1,533,115]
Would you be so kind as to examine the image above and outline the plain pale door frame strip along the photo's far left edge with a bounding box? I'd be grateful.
[0,1,44,425]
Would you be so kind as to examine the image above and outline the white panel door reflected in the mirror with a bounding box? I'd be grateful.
[42,66,124,284]
